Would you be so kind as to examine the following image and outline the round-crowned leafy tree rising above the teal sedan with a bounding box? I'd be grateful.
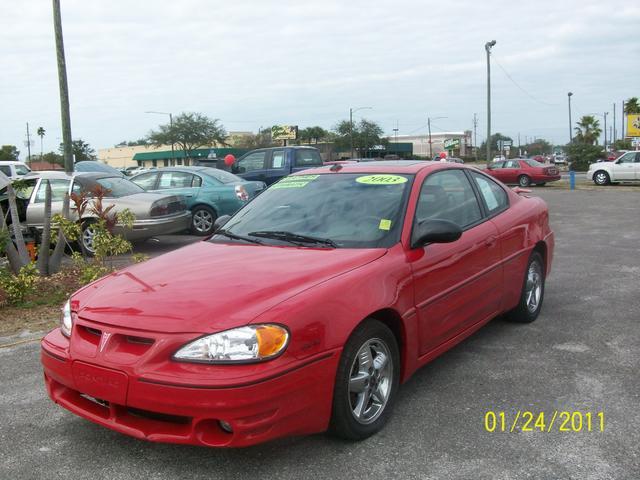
[147,112,227,158]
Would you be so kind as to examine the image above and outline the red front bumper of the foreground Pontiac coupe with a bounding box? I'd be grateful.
[41,325,340,447]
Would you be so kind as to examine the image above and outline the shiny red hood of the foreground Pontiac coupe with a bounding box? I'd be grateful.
[73,241,386,333]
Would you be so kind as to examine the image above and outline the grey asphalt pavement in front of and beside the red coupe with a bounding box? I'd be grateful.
[0,188,640,480]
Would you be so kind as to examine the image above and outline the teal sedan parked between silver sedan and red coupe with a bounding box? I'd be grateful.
[130,167,266,236]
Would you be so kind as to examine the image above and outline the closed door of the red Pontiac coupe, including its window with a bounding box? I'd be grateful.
[411,169,502,355]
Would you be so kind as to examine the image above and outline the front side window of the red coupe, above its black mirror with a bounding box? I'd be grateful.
[415,169,482,228]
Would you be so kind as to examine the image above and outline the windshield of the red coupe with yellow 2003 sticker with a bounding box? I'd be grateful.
[212,173,413,248]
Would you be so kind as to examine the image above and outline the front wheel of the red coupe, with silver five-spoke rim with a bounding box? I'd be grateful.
[329,319,400,440]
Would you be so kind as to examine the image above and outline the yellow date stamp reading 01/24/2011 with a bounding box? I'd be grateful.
[484,410,605,433]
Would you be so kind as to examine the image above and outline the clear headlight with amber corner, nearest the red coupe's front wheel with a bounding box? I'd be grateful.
[173,325,289,363]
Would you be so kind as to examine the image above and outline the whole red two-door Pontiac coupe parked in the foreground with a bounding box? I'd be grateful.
[42,161,554,447]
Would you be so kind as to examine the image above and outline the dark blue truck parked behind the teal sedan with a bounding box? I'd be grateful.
[231,146,322,185]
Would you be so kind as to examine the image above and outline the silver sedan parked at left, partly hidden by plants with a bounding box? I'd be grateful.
[10,171,191,254]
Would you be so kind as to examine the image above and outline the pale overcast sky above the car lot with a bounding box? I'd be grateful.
[0,0,640,158]
